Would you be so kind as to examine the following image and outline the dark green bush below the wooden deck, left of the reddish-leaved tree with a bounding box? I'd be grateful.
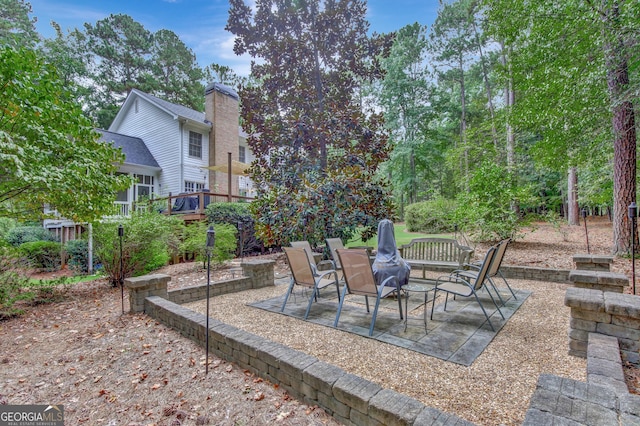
[205,203,264,256]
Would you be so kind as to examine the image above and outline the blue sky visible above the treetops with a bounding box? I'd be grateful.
[29,0,439,75]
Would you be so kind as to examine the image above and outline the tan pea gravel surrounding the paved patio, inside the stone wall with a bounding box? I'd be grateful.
[188,274,586,425]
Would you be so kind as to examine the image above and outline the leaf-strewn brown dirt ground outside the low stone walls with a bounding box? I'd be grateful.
[0,218,640,426]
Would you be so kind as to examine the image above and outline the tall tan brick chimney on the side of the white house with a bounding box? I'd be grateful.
[204,83,240,195]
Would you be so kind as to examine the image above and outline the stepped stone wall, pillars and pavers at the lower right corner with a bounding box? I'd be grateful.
[523,255,640,426]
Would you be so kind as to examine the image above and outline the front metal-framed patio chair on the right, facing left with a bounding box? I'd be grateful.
[431,246,504,331]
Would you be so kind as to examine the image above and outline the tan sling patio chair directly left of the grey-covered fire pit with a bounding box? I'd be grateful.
[333,249,403,336]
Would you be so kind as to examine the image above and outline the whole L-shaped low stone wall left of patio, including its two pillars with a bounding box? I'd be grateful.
[125,261,473,426]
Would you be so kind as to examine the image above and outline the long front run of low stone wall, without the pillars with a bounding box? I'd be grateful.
[145,296,472,426]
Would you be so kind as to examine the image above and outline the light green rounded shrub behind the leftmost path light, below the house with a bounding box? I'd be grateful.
[93,210,184,284]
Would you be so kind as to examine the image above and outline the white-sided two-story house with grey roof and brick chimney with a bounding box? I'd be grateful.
[44,83,254,241]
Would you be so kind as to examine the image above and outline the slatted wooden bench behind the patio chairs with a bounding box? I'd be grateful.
[398,237,473,278]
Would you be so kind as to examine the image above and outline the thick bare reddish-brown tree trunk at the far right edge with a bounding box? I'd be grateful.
[602,0,636,254]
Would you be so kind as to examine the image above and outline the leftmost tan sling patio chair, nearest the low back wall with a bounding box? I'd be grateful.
[280,247,340,319]
